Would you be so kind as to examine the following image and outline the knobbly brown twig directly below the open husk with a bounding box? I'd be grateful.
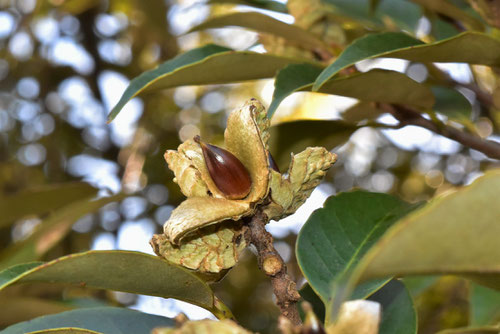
[248,211,301,325]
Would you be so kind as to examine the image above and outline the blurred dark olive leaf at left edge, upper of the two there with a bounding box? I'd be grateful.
[0,182,97,227]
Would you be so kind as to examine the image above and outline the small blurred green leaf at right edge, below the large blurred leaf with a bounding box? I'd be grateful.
[469,284,500,327]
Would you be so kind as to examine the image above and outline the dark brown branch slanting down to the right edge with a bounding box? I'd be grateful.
[380,103,500,160]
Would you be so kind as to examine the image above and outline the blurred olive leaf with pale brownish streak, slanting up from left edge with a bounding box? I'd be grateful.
[0,194,126,269]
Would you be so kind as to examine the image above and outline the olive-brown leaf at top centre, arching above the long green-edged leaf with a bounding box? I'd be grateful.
[188,12,327,50]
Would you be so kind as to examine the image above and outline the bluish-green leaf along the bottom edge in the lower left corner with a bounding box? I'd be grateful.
[0,307,174,334]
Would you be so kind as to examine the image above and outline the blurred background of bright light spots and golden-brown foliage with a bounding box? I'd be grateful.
[0,0,500,333]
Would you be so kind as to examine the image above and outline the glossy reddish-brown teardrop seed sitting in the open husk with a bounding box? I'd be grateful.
[193,136,252,199]
